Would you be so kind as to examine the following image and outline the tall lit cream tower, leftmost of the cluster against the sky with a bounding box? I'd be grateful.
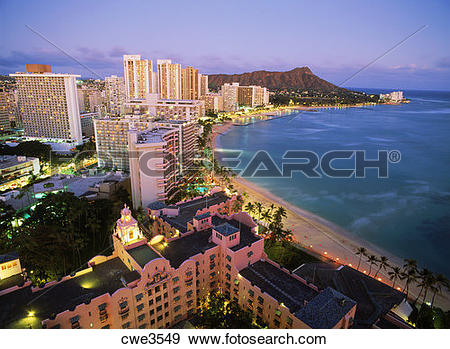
[123,55,156,100]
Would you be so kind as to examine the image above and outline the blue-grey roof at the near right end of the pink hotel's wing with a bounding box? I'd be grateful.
[294,287,356,328]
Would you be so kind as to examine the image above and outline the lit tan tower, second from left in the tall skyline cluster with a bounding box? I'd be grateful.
[156,59,182,99]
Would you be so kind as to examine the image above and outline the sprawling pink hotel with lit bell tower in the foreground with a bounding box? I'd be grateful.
[0,192,356,329]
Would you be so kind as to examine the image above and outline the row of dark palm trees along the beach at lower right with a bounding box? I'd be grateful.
[356,247,450,309]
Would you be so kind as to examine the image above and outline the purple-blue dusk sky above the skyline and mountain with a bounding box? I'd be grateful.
[0,0,450,90]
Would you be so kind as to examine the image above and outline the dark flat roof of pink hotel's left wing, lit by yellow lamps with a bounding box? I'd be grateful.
[0,258,137,328]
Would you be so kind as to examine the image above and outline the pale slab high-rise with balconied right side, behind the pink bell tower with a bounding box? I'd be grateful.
[128,127,180,208]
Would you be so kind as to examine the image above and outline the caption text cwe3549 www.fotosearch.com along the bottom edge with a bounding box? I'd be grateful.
[121,332,327,345]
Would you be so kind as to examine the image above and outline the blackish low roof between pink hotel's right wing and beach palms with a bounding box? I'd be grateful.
[295,263,405,328]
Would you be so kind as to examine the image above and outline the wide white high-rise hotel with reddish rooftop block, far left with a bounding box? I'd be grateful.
[10,64,82,143]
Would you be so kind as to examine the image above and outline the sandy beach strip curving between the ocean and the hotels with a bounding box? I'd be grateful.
[211,122,450,310]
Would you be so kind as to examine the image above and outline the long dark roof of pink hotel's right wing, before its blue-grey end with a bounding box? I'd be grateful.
[239,260,318,313]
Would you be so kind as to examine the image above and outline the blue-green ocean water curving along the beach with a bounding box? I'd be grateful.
[218,91,450,276]
